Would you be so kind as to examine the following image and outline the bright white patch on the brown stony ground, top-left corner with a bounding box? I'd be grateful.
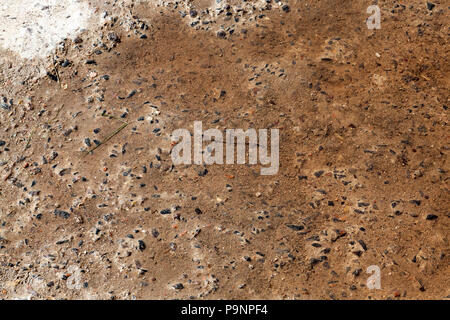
[0,0,93,59]
